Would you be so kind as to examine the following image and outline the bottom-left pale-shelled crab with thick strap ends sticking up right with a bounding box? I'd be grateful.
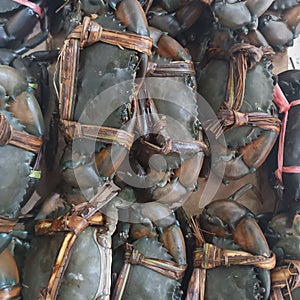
[22,184,123,299]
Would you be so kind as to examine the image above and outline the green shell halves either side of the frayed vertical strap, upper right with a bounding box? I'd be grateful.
[197,59,275,149]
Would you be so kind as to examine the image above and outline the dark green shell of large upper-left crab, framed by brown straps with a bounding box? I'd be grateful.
[74,14,138,156]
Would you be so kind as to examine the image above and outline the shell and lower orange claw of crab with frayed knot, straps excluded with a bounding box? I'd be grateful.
[197,51,278,179]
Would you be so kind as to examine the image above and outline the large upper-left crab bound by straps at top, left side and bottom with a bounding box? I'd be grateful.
[54,0,151,189]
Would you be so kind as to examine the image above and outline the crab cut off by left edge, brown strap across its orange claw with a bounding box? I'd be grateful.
[0,66,44,214]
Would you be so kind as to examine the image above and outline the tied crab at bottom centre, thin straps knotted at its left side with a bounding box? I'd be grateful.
[112,202,186,300]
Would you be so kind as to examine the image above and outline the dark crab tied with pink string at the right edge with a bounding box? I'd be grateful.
[274,70,300,206]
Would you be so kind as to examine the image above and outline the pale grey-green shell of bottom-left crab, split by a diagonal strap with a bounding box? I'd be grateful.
[22,227,111,300]
